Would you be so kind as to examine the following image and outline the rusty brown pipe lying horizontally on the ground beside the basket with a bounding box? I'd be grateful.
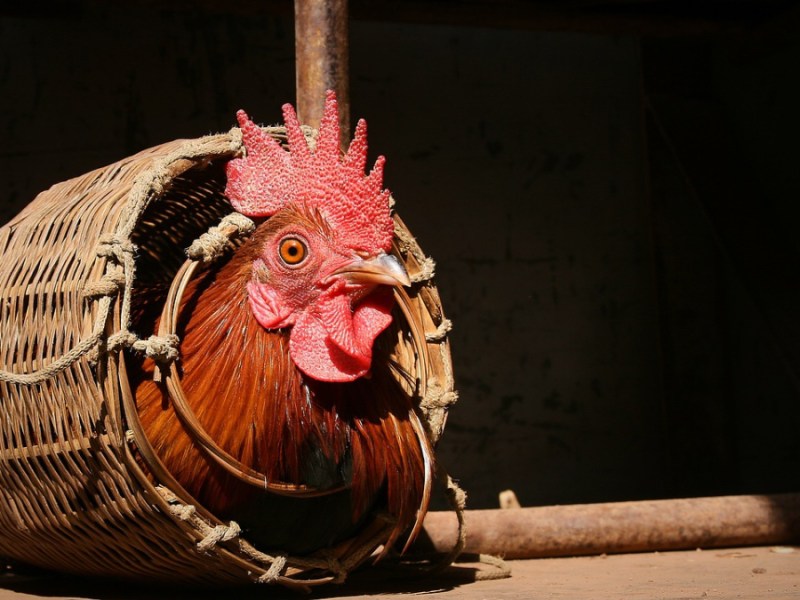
[422,494,800,558]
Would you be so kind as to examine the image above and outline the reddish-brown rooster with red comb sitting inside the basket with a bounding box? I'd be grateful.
[136,92,432,553]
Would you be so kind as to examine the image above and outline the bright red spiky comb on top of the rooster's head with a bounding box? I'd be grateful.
[225,91,394,252]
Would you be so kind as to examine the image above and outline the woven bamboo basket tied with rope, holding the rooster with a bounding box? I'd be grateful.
[0,128,456,587]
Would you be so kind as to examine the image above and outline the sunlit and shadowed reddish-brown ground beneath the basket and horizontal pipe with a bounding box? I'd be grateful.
[0,546,800,600]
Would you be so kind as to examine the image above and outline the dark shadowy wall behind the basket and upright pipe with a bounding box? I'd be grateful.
[0,0,800,508]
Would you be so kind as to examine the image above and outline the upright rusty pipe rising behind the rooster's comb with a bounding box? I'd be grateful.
[294,0,350,147]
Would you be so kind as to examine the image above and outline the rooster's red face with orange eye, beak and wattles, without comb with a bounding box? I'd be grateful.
[247,207,408,382]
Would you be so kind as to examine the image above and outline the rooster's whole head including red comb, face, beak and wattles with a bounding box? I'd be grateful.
[226,92,410,382]
